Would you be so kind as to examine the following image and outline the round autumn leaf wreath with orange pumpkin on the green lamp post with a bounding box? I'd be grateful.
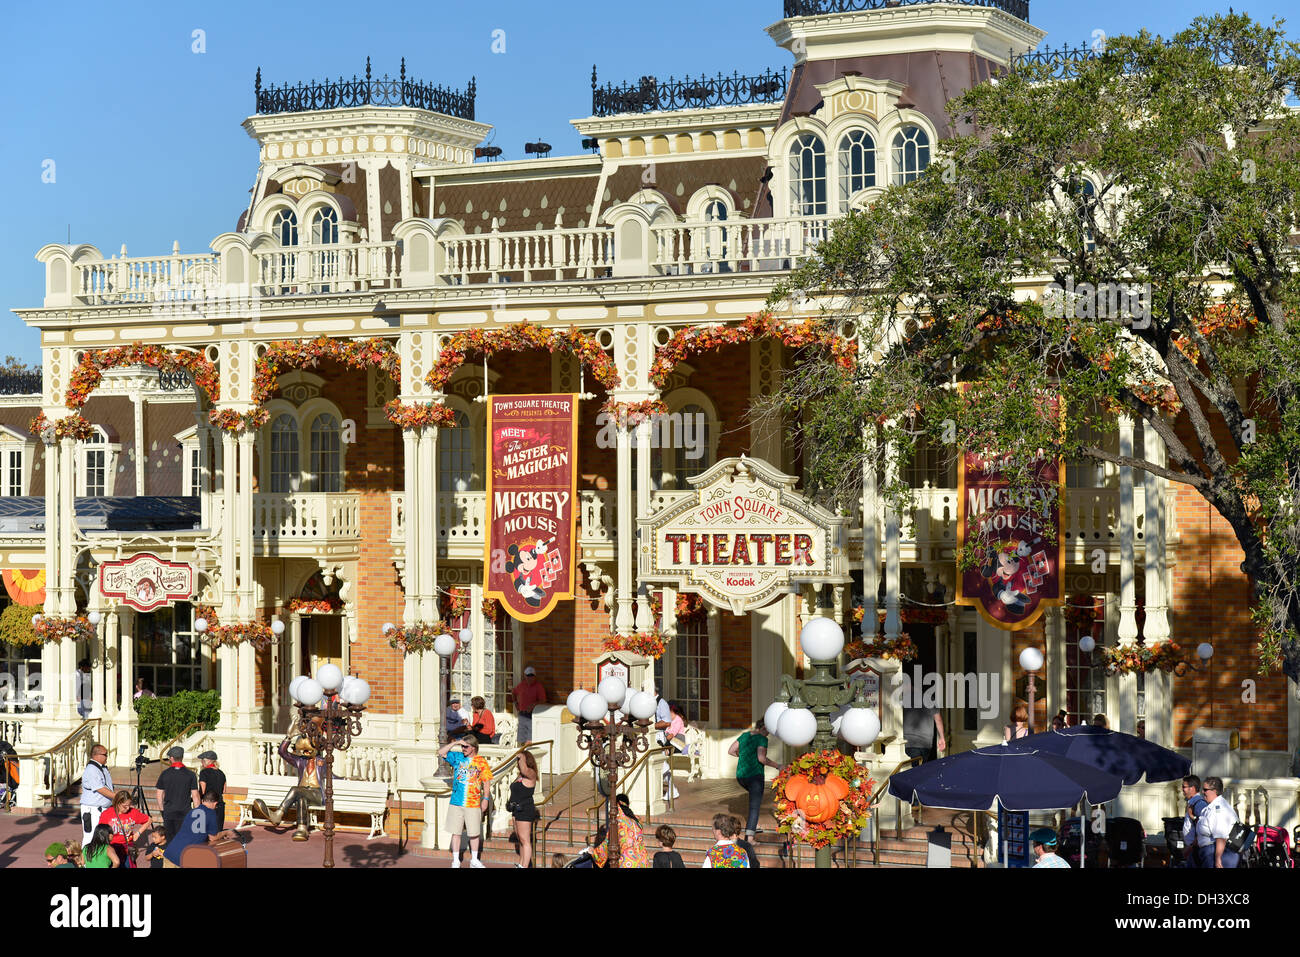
[772,750,876,848]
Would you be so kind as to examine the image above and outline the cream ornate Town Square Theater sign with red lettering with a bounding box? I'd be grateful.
[640,455,850,615]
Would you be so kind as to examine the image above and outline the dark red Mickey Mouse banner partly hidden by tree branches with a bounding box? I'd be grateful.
[957,452,1065,632]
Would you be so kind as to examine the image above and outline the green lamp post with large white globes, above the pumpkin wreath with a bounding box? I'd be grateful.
[763,618,880,867]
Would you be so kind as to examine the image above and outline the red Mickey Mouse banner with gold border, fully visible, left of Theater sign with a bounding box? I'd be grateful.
[484,394,577,622]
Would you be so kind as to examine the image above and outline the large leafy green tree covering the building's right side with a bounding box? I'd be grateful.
[757,14,1300,680]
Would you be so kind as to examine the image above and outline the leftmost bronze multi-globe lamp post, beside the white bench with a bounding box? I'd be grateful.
[289,664,371,867]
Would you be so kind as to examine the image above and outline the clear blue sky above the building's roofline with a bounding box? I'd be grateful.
[0,0,1300,361]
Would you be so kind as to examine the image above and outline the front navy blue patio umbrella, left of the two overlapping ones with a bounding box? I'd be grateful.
[889,745,1121,811]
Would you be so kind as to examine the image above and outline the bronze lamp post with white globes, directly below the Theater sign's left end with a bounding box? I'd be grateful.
[566,676,655,867]
